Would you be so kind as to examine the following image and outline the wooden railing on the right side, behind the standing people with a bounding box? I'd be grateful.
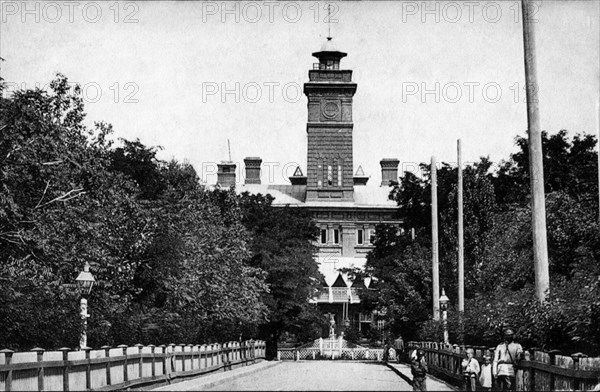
[409,342,600,391]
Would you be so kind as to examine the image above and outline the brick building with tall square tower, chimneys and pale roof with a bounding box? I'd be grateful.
[217,38,400,334]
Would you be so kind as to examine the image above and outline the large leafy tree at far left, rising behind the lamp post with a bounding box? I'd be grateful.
[0,76,147,347]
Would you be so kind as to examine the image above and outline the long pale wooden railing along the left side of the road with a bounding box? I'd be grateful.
[0,340,266,391]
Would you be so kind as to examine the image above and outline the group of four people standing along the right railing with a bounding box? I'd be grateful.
[410,329,523,391]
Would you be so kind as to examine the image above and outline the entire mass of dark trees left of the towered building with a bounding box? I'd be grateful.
[0,75,319,350]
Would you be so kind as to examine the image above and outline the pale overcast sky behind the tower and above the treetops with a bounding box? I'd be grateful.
[0,0,600,184]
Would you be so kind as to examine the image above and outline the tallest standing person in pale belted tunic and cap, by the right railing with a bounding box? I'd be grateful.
[493,328,523,391]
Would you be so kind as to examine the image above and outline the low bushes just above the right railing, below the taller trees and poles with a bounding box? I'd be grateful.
[418,276,600,356]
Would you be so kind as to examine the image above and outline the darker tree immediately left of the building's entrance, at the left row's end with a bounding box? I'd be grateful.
[211,189,323,356]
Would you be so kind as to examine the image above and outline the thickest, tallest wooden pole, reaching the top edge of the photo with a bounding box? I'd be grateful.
[521,0,550,301]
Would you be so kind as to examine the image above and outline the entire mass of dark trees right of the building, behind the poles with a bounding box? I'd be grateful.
[367,131,600,355]
